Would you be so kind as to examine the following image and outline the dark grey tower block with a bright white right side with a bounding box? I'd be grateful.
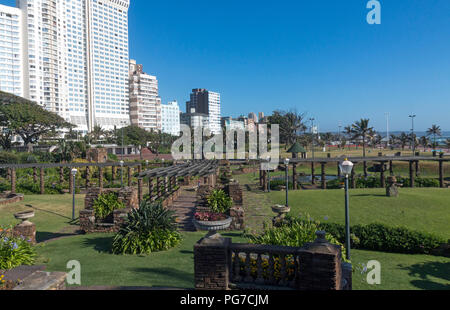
[186,88,221,134]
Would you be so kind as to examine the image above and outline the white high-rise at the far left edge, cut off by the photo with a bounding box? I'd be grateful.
[0,5,24,97]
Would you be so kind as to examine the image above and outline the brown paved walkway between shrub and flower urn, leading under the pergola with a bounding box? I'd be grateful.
[169,189,197,231]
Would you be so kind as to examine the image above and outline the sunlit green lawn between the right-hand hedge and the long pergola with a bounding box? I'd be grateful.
[267,188,450,238]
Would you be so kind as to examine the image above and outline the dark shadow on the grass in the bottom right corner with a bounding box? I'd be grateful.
[400,262,450,290]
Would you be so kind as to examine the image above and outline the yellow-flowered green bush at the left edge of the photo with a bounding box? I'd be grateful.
[0,228,36,270]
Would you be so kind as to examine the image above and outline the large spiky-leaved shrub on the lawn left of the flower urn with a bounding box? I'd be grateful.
[113,201,181,254]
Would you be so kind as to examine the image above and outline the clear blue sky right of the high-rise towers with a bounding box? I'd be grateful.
[0,0,450,131]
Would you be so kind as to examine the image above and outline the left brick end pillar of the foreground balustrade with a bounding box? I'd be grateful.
[194,234,231,290]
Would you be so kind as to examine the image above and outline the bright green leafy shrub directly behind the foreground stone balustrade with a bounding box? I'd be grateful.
[249,216,346,260]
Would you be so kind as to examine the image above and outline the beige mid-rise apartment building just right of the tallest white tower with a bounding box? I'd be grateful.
[129,60,162,131]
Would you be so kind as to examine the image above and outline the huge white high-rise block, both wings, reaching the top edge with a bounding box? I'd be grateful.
[17,0,130,132]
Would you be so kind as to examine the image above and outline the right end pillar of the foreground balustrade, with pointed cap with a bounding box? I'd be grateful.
[298,231,342,291]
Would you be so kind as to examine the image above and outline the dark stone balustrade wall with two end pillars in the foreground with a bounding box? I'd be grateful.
[194,232,352,290]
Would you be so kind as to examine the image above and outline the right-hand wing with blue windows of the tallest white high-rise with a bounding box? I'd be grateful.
[86,0,130,129]
